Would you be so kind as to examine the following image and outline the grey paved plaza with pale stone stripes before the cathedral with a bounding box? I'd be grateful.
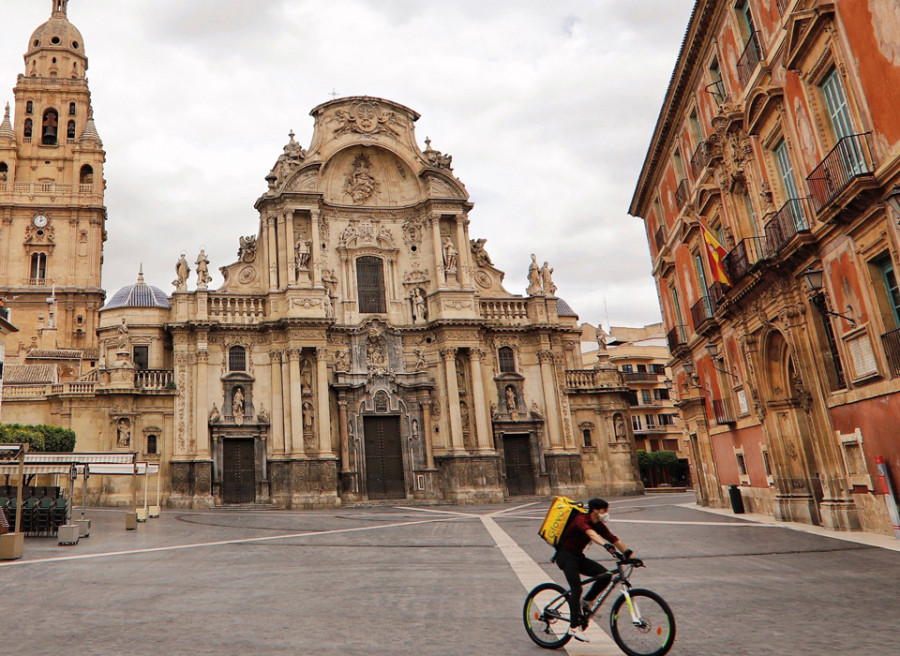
[0,494,900,656]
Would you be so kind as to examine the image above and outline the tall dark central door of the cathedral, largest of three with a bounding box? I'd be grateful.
[363,417,406,499]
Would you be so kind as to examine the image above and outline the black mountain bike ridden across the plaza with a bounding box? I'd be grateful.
[523,545,675,656]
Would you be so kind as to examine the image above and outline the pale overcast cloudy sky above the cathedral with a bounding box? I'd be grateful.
[0,0,693,326]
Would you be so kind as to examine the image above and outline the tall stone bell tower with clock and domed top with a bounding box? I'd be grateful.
[0,0,106,357]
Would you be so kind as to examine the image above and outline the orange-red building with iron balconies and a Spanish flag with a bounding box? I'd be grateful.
[630,0,900,534]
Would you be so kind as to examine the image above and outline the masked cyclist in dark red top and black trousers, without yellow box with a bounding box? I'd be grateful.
[555,499,632,642]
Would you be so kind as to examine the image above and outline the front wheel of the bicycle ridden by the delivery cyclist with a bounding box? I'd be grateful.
[609,589,675,656]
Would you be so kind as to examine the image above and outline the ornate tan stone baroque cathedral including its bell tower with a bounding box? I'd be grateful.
[0,1,641,508]
